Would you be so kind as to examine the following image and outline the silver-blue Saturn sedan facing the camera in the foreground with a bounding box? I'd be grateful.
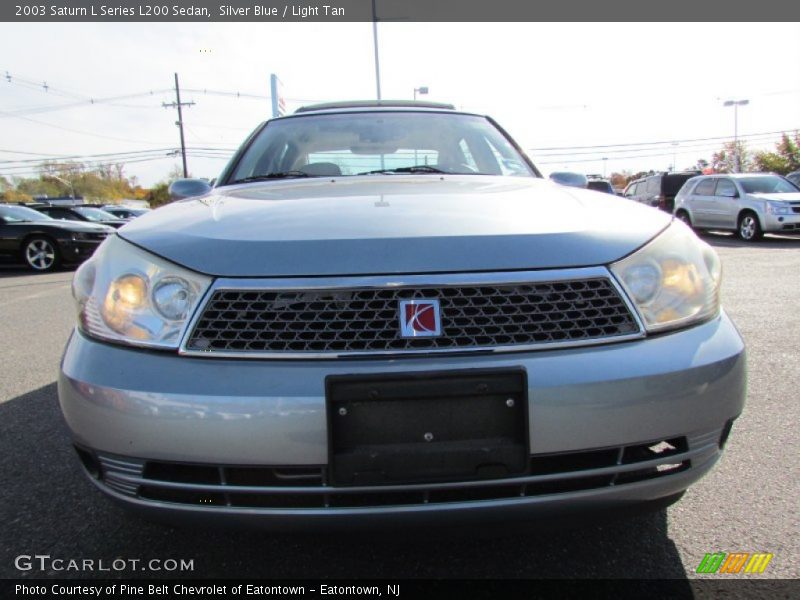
[58,102,745,528]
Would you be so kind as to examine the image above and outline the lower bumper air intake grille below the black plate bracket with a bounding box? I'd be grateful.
[78,430,708,510]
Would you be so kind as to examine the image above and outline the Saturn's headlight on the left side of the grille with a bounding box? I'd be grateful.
[72,236,211,348]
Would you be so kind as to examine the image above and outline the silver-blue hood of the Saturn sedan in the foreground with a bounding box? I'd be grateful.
[119,175,671,277]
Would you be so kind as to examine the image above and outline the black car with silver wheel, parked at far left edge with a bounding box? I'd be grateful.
[0,204,114,272]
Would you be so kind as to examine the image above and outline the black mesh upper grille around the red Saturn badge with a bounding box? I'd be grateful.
[185,277,640,356]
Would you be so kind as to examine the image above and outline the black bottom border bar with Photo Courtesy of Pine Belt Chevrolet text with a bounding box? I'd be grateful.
[0,574,800,600]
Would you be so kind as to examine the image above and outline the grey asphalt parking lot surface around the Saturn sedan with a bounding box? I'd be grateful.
[0,234,800,579]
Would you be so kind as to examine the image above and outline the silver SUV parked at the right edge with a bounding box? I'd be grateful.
[675,173,800,242]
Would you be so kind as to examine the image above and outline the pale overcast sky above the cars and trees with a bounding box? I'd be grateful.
[0,23,800,185]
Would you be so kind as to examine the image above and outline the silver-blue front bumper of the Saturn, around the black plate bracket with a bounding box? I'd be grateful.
[58,313,745,528]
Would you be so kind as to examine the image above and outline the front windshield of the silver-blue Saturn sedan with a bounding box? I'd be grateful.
[225,111,534,184]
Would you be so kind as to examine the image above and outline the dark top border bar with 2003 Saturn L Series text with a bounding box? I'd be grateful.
[6,0,800,22]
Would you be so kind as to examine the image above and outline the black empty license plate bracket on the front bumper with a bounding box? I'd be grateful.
[326,368,530,486]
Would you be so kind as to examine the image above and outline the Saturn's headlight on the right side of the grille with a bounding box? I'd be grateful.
[611,221,722,331]
